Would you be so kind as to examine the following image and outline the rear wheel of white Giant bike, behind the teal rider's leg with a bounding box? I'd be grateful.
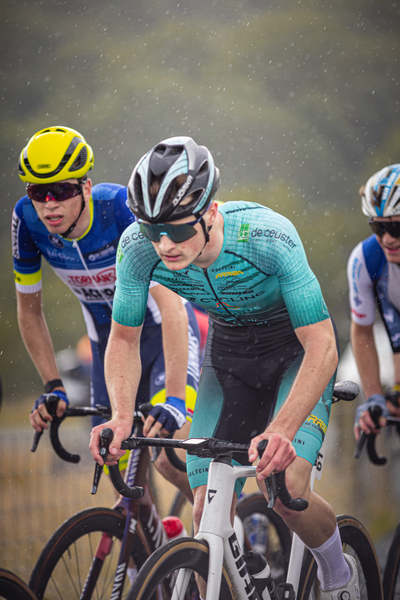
[298,515,383,600]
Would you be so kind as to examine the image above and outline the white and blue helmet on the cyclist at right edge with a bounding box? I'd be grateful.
[361,164,400,217]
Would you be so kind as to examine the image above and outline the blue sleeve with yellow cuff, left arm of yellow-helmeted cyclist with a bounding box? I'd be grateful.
[11,199,42,294]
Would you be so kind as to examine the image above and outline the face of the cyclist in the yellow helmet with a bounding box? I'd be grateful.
[32,179,92,235]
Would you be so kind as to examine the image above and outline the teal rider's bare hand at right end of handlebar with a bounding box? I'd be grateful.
[249,429,296,481]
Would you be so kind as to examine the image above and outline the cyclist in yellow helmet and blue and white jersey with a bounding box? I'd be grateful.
[12,127,200,498]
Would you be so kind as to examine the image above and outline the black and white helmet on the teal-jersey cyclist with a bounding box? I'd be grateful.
[128,136,220,223]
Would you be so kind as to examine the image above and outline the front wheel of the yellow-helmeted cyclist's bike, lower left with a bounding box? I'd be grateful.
[29,508,148,600]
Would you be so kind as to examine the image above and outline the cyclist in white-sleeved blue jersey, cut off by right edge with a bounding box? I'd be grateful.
[347,164,400,439]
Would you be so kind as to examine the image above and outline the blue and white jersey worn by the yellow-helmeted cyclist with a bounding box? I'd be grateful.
[12,183,161,342]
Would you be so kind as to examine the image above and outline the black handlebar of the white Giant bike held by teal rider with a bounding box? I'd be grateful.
[99,429,308,511]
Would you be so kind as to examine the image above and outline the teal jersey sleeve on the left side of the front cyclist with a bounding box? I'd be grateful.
[112,223,151,327]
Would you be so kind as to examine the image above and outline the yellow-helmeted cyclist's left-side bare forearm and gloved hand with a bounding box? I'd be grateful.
[16,291,67,431]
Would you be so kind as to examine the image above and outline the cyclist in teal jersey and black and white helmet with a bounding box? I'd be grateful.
[90,137,359,600]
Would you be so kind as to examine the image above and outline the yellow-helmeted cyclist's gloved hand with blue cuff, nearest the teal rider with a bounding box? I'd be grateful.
[143,396,186,437]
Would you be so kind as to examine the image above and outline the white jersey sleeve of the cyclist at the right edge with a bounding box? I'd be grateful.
[347,242,375,326]
